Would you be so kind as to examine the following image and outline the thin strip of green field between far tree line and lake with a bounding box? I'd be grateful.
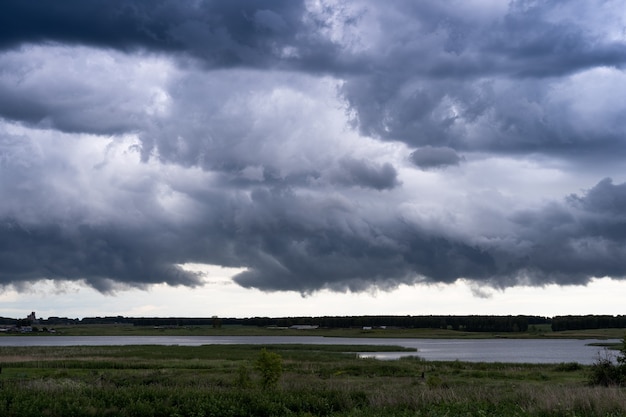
[22,324,626,339]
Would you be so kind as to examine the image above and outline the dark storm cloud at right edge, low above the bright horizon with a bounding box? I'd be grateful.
[502,178,626,284]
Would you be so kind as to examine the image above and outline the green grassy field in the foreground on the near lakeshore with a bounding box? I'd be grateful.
[0,345,626,417]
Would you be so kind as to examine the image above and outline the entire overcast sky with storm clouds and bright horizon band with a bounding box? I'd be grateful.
[0,0,626,317]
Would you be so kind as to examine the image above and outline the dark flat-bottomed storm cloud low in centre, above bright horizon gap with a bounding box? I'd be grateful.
[229,222,495,292]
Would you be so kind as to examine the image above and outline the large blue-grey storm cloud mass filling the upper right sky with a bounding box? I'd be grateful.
[342,2,626,154]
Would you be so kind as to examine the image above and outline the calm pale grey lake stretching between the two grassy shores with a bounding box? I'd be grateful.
[0,335,619,364]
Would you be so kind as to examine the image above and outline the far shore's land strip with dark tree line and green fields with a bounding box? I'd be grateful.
[6,315,626,339]
